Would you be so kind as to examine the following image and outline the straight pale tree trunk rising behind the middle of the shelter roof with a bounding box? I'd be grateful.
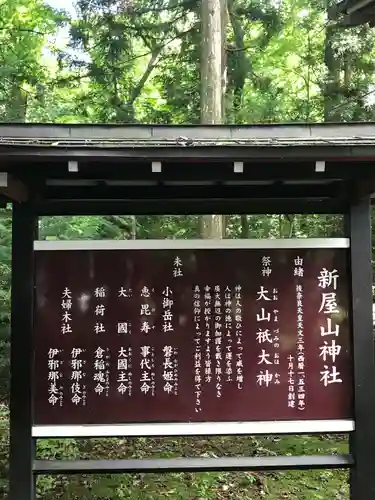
[200,0,225,238]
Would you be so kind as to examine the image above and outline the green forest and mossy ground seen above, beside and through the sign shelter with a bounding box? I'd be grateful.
[0,0,375,500]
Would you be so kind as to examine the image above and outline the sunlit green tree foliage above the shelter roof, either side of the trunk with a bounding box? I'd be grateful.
[0,0,375,123]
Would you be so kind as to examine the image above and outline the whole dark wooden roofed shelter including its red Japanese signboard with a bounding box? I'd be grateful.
[0,124,375,500]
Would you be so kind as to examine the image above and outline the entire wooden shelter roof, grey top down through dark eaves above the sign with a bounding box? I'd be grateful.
[0,123,375,214]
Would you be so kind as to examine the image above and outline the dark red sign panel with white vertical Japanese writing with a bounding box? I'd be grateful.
[34,244,352,425]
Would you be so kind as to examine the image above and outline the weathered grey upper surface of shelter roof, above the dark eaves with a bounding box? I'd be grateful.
[0,123,375,157]
